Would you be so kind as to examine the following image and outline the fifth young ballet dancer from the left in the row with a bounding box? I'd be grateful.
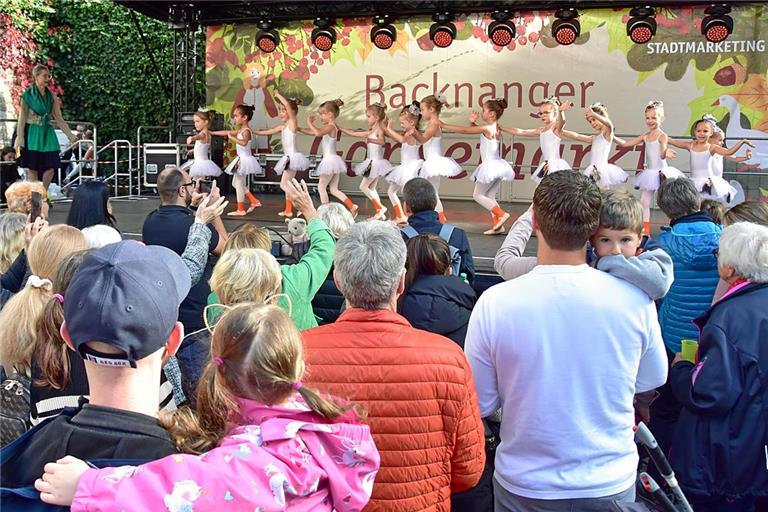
[338,103,392,220]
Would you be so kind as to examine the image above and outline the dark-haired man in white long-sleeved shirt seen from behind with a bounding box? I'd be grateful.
[465,172,667,512]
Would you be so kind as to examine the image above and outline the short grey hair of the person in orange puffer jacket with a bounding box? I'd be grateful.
[333,221,406,310]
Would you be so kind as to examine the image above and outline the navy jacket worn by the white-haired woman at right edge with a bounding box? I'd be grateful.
[669,283,768,497]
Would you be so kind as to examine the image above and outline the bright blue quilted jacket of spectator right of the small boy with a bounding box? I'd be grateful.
[658,212,723,354]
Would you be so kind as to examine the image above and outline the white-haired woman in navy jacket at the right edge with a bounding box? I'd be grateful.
[669,222,768,512]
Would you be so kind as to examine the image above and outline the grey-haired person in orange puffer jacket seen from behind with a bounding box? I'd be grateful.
[302,221,485,512]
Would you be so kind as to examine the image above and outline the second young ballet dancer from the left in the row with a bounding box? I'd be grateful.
[210,105,261,217]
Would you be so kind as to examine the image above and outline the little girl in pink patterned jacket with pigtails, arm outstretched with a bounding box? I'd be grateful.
[35,304,379,512]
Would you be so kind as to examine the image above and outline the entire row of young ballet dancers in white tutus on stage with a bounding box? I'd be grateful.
[184,90,753,235]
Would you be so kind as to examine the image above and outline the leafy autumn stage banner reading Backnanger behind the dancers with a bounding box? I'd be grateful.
[206,4,768,200]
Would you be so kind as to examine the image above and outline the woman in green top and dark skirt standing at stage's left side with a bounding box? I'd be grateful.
[16,64,76,190]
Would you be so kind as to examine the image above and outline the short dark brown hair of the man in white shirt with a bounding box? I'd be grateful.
[533,172,602,251]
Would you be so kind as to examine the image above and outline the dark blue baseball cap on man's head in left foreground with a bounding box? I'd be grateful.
[64,240,191,368]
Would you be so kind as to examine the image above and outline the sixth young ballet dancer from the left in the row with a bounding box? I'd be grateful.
[384,101,424,224]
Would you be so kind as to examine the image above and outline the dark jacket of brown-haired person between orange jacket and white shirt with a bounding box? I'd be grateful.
[397,276,477,348]
